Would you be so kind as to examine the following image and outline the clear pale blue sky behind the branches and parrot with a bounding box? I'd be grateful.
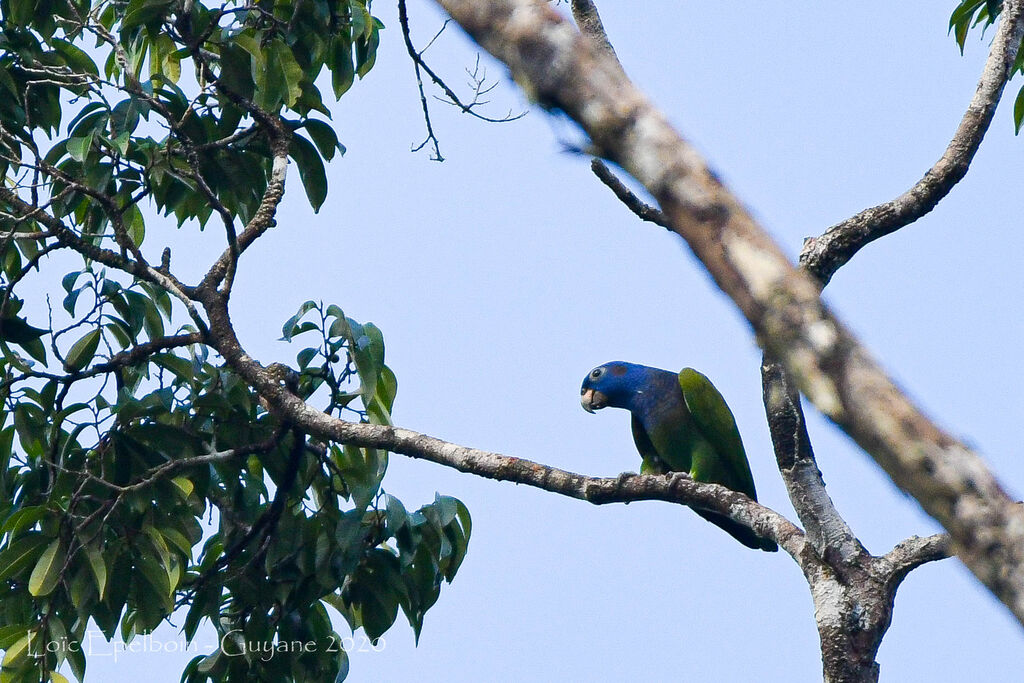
[89,0,1024,683]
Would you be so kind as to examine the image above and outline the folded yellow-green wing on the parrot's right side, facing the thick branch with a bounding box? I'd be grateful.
[679,368,758,501]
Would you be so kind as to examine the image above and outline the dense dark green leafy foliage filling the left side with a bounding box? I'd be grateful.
[0,0,471,682]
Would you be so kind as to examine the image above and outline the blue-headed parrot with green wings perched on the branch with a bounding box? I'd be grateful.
[580,360,778,552]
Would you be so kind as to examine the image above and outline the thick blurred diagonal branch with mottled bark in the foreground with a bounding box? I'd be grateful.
[430,0,1024,621]
